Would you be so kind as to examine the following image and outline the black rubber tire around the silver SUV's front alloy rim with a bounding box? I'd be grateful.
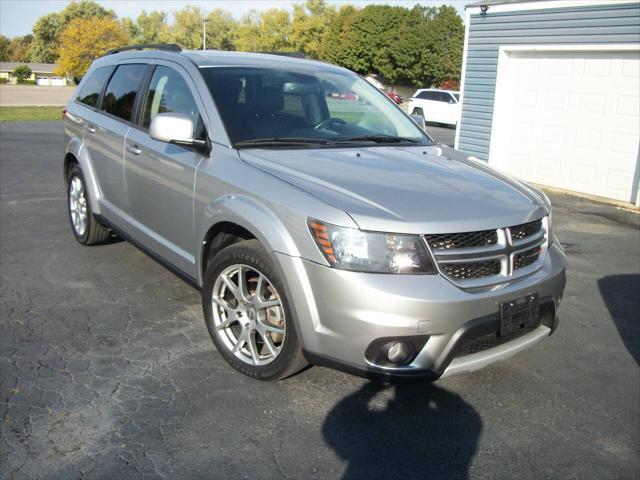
[202,240,308,380]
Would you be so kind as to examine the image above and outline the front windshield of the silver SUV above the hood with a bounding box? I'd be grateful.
[201,65,432,147]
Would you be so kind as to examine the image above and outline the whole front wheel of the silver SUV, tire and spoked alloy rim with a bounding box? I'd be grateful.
[202,240,306,380]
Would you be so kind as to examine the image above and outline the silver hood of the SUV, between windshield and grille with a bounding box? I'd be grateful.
[239,145,547,233]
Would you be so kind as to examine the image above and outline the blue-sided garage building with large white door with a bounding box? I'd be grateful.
[455,0,640,205]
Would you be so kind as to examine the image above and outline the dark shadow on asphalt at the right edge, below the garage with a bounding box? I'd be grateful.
[598,274,640,365]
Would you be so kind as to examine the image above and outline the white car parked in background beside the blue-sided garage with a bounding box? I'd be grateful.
[408,88,460,127]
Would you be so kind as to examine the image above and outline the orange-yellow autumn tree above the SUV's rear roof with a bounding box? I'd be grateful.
[58,17,129,78]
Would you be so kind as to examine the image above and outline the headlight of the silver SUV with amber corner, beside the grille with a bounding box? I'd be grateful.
[308,219,437,274]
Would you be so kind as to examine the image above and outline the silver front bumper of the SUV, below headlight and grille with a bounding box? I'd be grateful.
[276,241,565,379]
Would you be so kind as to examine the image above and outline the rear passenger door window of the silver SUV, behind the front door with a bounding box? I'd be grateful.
[101,64,147,122]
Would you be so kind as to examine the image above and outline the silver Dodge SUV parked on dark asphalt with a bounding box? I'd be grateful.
[64,45,565,379]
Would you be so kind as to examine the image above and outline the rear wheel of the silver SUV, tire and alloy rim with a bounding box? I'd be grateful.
[67,164,111,245]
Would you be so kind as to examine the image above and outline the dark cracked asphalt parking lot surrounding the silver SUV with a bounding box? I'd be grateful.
[0,122,640,480]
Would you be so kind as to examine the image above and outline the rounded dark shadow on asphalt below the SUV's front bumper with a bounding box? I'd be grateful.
[322,382,482,480]
